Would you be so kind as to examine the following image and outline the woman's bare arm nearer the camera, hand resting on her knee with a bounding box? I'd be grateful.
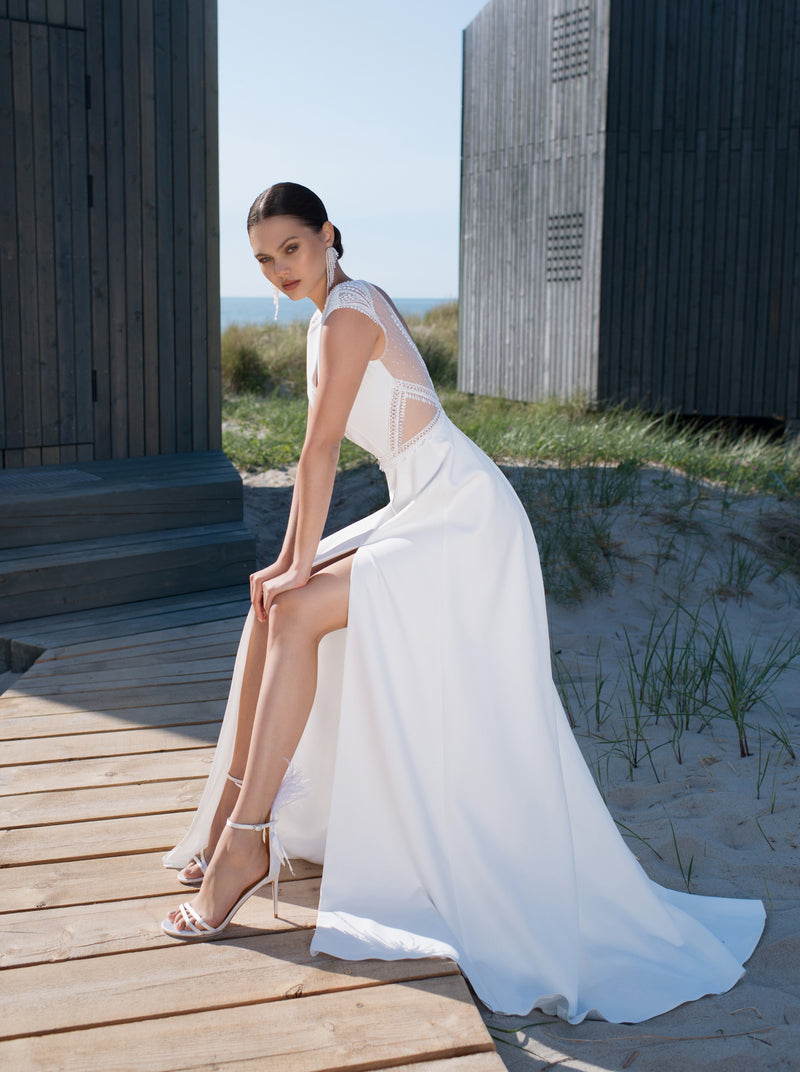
[251,309,383,622]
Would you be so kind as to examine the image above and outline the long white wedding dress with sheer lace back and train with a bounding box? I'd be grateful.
[165,281,765,1023]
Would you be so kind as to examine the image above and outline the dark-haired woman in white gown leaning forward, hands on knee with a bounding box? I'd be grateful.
[163,183,764,1023]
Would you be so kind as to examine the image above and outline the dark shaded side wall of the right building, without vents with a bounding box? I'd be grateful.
[597,0,800,418]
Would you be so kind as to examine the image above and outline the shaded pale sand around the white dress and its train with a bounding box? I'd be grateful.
[242,466,800,1072]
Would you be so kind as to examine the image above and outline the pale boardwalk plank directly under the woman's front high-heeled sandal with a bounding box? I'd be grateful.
[0,883,320,969]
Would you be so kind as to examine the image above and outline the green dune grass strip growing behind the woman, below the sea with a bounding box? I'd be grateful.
[222,302,800,496]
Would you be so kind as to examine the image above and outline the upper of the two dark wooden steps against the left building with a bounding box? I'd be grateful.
[0,450,242,548]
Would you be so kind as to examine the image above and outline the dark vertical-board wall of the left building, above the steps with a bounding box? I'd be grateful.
[0,0,220,466]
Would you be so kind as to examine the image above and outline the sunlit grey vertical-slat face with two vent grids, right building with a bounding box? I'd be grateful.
[459,0,608,400]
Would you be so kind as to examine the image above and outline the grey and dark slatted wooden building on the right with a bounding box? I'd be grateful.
[459,0,800,421]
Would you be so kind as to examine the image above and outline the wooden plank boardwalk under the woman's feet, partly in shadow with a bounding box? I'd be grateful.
[0,589,503,1072]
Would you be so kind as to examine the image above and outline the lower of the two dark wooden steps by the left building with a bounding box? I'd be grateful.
[0,521,255,622]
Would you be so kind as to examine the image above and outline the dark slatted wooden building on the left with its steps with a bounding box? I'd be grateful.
[0,0,254,622]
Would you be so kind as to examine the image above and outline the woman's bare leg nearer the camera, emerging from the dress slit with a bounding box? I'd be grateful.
[169,554,353,927]
